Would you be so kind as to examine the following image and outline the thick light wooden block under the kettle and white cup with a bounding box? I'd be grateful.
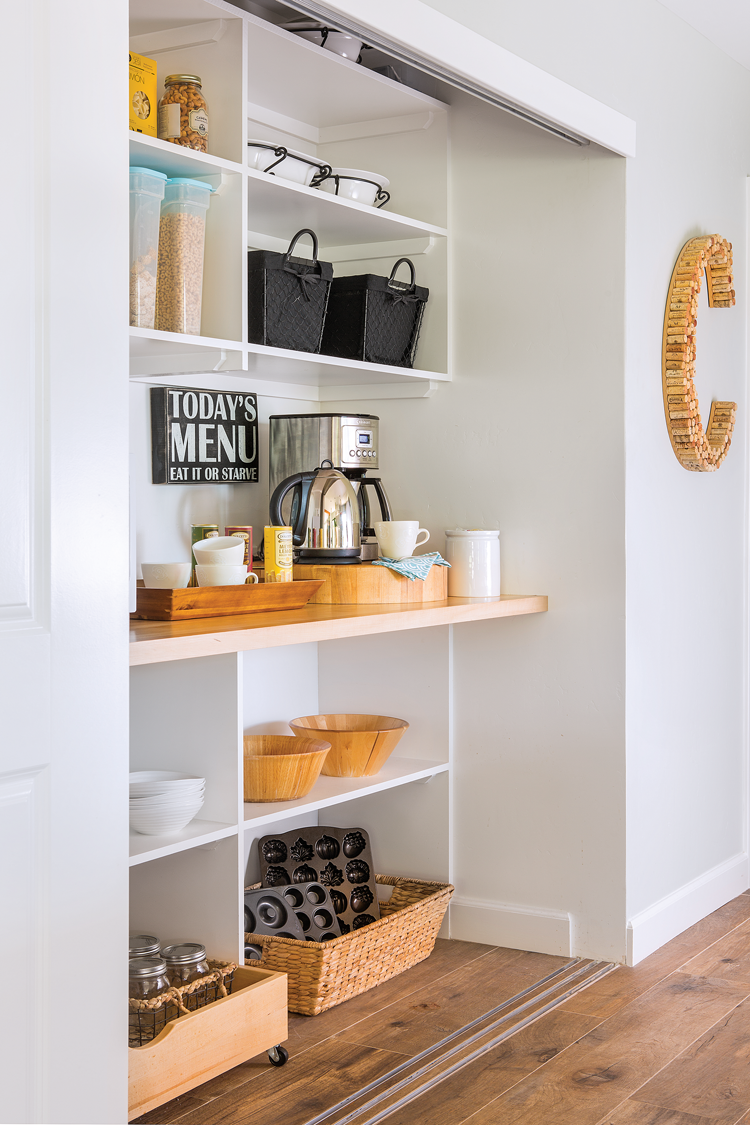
[295,563,448,605]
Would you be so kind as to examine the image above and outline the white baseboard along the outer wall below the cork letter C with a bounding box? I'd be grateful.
[627,852,750,965]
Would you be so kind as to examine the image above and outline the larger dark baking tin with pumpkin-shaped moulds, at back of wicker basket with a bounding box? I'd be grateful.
[257,826,380,934]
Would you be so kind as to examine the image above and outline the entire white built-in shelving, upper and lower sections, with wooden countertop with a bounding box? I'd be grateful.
[125,0,545,1107]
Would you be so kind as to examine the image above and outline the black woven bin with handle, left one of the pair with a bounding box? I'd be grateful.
[247,230,333,352]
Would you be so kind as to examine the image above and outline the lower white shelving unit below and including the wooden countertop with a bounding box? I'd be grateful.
[130,596,546,959]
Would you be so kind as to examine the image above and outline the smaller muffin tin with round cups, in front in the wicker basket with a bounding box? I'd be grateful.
[245,883,344,940]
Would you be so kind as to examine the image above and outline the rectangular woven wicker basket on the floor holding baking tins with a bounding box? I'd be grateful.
[245,875,453,1016]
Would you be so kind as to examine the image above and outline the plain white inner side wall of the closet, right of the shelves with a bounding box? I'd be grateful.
[330,92,625,959]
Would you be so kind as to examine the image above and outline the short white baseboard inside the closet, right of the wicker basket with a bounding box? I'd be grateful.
[450,896,570,957]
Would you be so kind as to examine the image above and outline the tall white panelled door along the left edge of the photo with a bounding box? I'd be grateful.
[0,0,128,1125]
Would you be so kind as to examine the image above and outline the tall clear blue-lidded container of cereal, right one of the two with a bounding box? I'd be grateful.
[156,177,213,336]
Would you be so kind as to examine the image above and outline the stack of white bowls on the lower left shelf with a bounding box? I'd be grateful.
[130,770,206,836]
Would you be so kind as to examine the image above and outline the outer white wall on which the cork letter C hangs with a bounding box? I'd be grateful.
[413,0,750,960]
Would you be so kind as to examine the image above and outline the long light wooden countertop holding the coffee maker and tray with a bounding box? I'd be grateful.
[130,594,548,666]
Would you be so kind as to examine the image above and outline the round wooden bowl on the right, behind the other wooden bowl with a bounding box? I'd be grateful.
[289,714,409,777]
